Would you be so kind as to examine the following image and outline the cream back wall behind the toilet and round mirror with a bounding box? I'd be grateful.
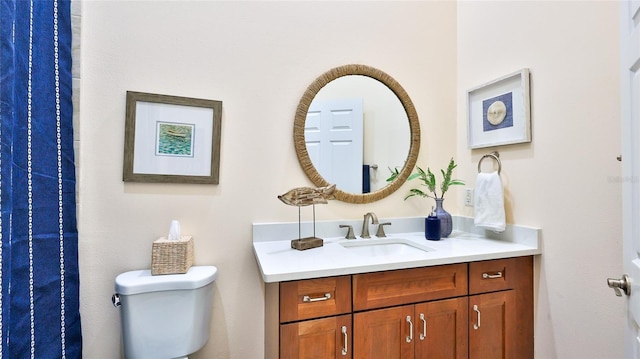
[78,1,456,359]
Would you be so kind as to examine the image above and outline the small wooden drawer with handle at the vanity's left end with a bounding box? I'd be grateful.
[280,276,351,323]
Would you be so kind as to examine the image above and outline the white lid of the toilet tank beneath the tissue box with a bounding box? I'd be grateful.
[115,266,218,295]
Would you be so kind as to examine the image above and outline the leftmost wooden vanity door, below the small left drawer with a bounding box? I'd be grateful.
[280,314,352,359]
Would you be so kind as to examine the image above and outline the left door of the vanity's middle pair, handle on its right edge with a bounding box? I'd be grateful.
[353,305,416,359]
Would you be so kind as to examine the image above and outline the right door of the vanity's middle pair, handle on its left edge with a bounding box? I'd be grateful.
[415,297,469,359]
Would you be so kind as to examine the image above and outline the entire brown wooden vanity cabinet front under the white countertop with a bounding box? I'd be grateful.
[280,256,533,359]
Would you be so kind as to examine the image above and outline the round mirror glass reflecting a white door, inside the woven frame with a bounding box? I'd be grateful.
[305,75,411,193]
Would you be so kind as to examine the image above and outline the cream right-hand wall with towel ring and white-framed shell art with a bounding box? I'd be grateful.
[457,1,624,359]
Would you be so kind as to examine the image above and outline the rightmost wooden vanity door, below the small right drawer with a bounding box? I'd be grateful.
[469,290,519,359]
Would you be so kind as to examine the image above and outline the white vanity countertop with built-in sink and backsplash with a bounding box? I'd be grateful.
[253,217,542,283]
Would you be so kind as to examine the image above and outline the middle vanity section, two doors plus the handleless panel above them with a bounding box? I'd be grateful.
[353,263,468,359]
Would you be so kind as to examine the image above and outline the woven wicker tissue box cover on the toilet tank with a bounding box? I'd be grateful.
[151,236,193,275]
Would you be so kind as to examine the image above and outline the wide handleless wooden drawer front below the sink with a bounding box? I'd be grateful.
[353,263,467,311]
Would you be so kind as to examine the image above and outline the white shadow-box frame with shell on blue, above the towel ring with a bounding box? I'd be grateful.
[467,68,531,149]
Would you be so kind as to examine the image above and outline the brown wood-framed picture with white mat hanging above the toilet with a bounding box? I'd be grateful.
[122,91,222,184]
